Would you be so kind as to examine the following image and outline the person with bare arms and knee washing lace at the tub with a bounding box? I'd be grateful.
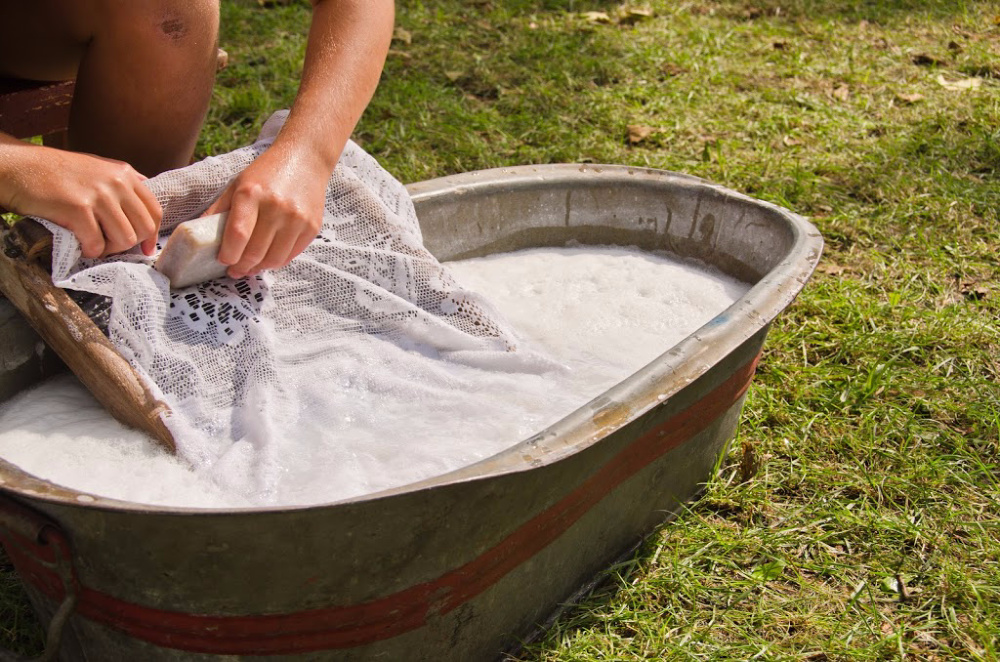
[0,0,394,277]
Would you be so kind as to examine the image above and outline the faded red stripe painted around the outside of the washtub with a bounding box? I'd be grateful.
[5,355,760,655]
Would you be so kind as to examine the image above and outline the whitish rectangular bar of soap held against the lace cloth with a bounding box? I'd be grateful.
[154,212,229,289]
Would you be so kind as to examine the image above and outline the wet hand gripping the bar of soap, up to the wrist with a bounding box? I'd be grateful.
[205,142,330,278]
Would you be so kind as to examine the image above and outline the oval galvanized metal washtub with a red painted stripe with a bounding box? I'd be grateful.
[0,165,822,660]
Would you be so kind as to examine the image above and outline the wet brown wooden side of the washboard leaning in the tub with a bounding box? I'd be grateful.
[0,230,177,453]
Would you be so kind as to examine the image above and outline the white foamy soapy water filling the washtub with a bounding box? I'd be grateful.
[0,247,748,509]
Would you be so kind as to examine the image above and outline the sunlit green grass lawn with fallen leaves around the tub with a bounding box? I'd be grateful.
[0,0,1000,660]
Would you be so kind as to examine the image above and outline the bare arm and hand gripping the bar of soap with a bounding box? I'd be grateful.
[207,0,395,278]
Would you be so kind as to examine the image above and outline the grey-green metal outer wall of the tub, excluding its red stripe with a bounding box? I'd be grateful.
[7,333,763,660]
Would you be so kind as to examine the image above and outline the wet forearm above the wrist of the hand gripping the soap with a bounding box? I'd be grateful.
[275,0,395,172]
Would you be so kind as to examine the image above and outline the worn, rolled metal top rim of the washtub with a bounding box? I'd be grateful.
[0,163,823,516]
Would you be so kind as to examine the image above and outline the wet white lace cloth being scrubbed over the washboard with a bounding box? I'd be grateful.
[37,113,551,502]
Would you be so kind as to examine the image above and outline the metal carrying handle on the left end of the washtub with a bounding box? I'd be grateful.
[0,494,79,662]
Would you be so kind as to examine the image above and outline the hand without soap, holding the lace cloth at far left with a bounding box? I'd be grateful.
[0,141,163,258]
